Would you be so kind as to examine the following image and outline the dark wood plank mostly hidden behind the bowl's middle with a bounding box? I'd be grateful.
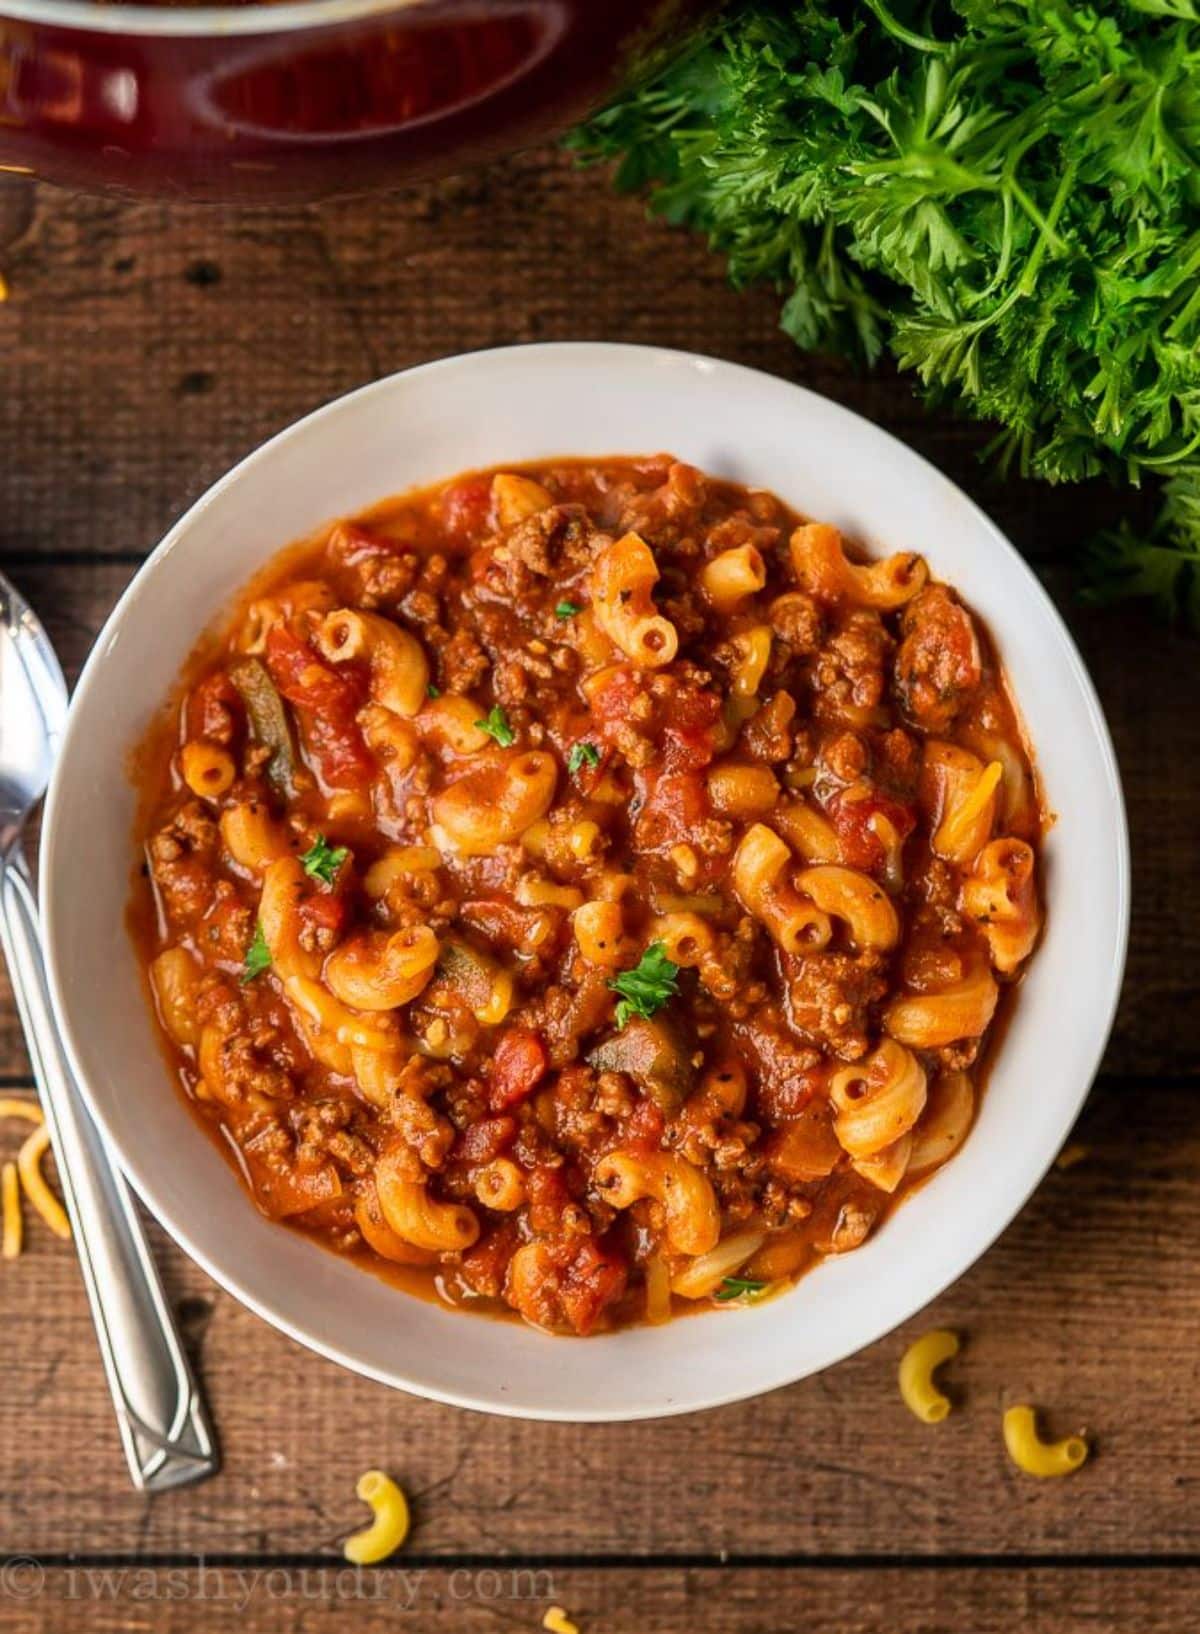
[0,559,1200,1077]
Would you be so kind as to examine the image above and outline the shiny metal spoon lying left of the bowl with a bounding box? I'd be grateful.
[0,574,219,1492]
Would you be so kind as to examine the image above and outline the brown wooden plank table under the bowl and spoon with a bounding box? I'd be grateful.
[0,154,1200,1634]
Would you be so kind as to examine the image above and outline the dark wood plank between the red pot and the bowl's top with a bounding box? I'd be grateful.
[0,150,1151,575]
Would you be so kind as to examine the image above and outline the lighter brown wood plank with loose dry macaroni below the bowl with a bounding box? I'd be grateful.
[0,1085,1200,1555]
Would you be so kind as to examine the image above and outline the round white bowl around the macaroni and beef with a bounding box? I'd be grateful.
[41,345,1130,1420]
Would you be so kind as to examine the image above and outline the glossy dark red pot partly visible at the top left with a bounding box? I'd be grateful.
[0,0,708,201]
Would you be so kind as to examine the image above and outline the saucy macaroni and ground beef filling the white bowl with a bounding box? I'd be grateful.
[131,456,1041,1333]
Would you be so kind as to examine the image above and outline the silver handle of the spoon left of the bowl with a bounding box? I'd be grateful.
[0,850,221,1492]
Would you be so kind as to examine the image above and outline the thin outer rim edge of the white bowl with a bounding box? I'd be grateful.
[39,342,1131,1423]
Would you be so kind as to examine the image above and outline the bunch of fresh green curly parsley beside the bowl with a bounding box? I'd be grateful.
[574,0,1200,626]
